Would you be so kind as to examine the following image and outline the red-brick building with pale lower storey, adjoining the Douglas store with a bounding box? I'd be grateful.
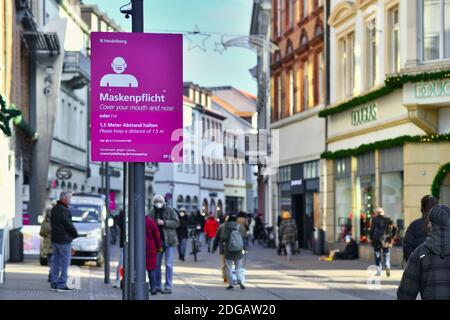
[271,0,325,249]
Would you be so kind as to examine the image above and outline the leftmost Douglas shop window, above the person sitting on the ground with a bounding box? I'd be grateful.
[334,178,353,241]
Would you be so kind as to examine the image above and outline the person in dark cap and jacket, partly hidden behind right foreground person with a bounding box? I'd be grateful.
[403,195,437,262]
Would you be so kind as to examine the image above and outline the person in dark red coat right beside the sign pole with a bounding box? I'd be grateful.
[145,216,162,296]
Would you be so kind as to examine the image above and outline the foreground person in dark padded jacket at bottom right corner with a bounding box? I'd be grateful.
[397,204,450,300]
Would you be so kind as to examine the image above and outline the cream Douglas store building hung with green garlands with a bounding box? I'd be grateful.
[320,0,450,264]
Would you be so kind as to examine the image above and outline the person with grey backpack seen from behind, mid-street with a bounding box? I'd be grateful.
[220,215,246,290]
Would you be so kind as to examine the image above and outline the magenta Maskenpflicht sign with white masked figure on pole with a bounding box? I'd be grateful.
[91,32,183,162]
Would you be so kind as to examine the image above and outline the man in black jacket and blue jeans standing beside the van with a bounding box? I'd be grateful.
[50,192,78,292]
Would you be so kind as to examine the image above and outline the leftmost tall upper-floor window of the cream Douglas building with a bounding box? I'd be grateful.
[340,32,355,98]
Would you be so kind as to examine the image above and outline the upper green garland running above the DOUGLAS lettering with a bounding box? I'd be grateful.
[319,70,450,118]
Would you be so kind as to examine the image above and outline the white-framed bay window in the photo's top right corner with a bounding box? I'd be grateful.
[422,0,450,61]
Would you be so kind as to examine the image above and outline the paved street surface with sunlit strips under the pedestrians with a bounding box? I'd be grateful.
[0,242,402,300]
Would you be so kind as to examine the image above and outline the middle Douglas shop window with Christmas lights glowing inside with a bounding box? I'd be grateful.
[356,175,375,243]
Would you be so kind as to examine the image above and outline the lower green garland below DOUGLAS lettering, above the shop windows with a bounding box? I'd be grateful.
[320,133,450,160]
